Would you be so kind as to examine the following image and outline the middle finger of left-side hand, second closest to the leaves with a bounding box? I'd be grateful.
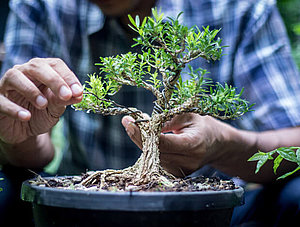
[19,58,72,100]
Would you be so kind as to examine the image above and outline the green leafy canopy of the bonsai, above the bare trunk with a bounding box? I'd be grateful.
[74,9,251,119]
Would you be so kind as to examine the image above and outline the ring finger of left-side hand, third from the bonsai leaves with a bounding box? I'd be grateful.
[0,68,48,109]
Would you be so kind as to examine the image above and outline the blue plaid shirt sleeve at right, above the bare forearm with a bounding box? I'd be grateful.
[233,1,300,131]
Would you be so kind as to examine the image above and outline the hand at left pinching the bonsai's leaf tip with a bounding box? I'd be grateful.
[0,58,83,144]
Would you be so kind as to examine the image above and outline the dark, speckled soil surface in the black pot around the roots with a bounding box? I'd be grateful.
[30,172,237,192]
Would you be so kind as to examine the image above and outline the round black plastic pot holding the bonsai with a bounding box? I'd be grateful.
[22,181,244,227]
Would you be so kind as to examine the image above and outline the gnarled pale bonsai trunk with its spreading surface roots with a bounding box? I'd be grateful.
[81,114,176,190]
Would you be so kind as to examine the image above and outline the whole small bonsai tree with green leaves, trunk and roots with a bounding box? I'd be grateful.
[74,9,250,190]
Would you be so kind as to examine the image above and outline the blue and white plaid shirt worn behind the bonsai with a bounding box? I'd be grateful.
[1,0,300,173]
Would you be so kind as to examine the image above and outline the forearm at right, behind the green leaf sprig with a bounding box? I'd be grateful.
[211,127,300,183]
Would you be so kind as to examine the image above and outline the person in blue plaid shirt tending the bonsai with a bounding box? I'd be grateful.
[0,0,300,225]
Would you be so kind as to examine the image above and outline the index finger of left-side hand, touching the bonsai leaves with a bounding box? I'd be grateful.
[46,58,83,97]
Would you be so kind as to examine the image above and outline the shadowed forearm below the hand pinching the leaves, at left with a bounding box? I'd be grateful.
[0,133,54,168]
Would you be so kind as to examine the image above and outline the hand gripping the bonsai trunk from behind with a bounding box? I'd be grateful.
[122,114,231,177]
